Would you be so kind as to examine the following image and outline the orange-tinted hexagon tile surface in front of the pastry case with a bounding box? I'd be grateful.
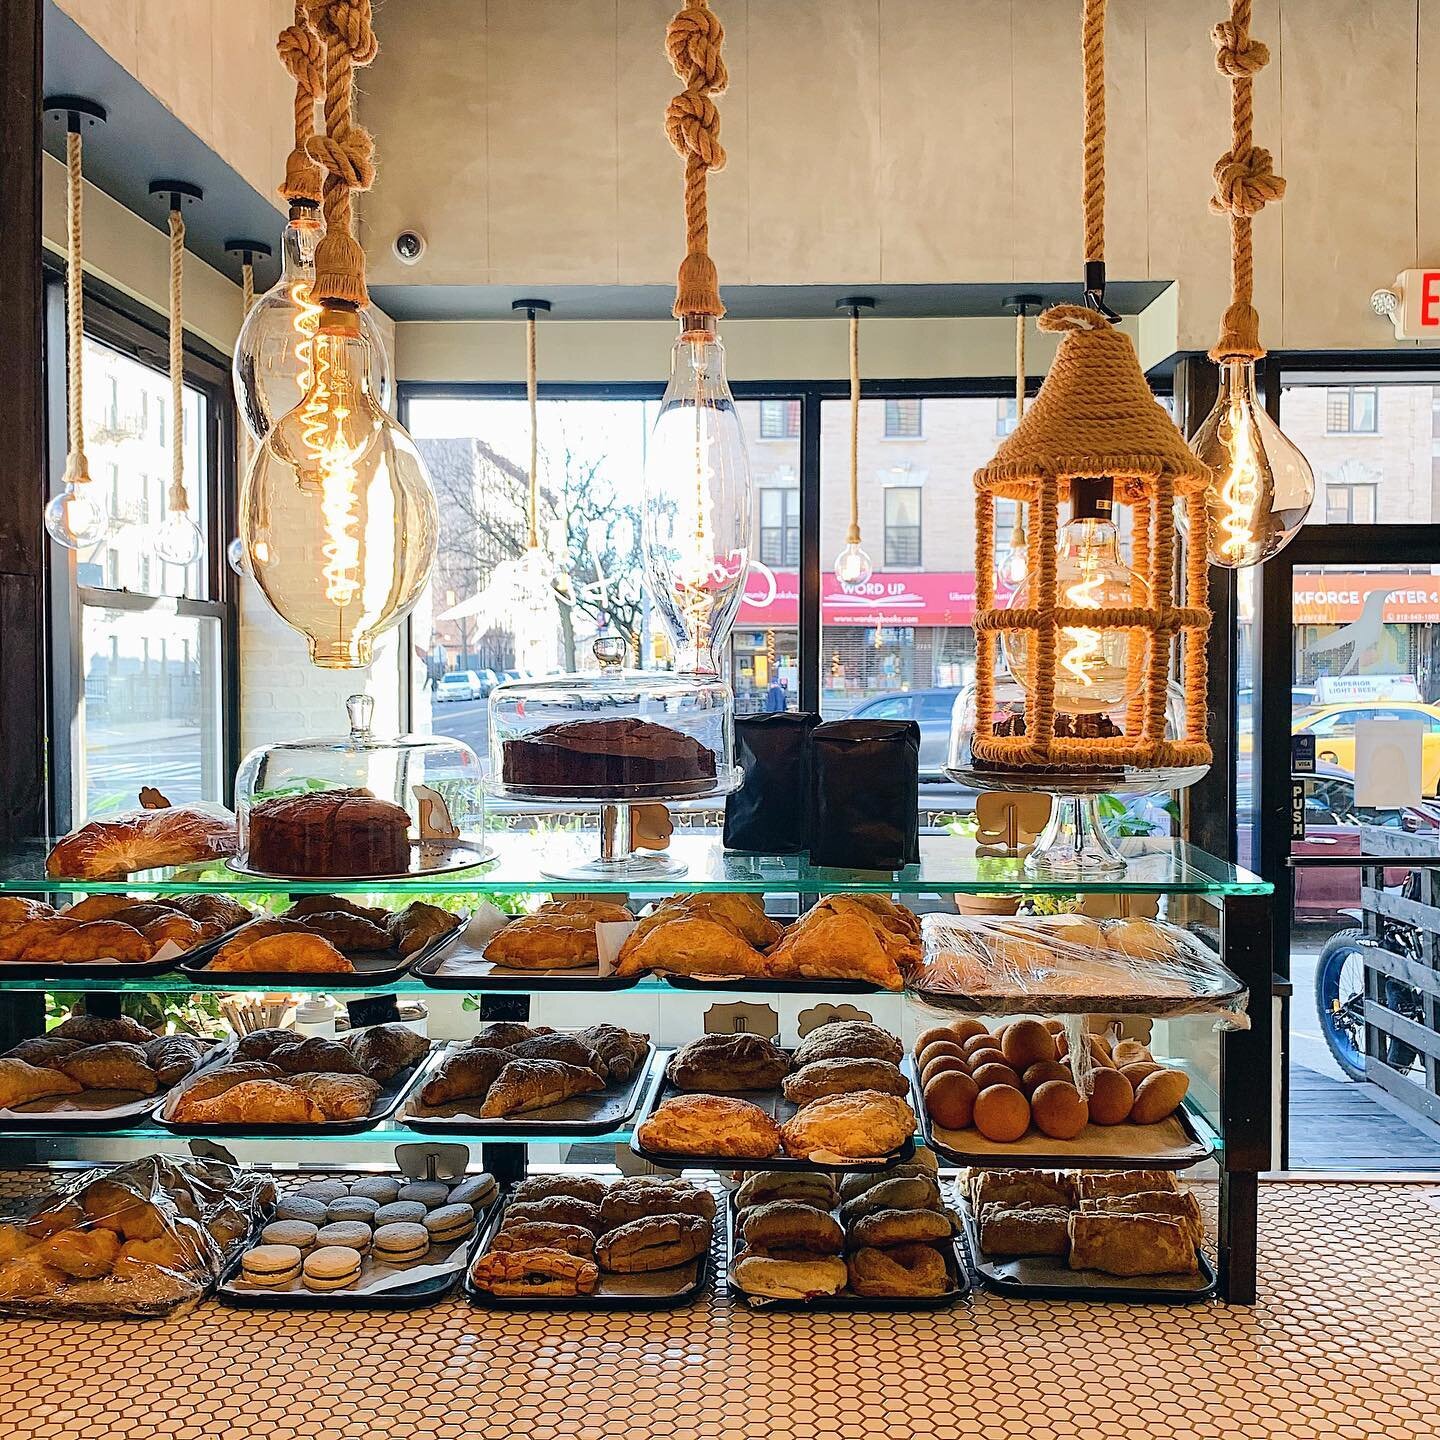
[0,1184,1440,1440]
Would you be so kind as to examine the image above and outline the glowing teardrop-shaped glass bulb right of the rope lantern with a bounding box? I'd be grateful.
[1181,360,1315,570]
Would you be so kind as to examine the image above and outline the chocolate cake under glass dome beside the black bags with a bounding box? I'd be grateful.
[503,717,716,799]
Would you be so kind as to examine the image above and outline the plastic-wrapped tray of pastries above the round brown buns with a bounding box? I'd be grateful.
[906,914,1250,1038]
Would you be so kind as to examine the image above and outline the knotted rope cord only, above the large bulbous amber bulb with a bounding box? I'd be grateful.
[305,0,379,310]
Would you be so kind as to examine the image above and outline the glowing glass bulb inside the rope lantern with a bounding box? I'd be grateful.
[1004,480,1149,714]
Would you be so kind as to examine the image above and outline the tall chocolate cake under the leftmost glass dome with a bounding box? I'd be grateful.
[249,789,410,878]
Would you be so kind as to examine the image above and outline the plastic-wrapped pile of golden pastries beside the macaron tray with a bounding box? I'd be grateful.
[0,1155,275,1318]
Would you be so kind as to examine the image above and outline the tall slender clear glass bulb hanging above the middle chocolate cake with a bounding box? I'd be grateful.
[644,315,752,675]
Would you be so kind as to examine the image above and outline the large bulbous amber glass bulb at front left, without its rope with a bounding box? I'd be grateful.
[240,305,438,670]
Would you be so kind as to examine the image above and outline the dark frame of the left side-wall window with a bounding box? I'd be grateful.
[43,255,240,834]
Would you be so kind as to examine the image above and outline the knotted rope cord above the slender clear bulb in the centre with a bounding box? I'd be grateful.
[665,0,730,320]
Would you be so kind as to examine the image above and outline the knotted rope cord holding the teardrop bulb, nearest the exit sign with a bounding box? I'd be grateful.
[1210,0,1284,361]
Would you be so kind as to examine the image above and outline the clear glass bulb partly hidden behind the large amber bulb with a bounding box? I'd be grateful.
[230,204,392,441]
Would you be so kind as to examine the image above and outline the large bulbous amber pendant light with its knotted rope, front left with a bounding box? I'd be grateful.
[240,0,438,670]
